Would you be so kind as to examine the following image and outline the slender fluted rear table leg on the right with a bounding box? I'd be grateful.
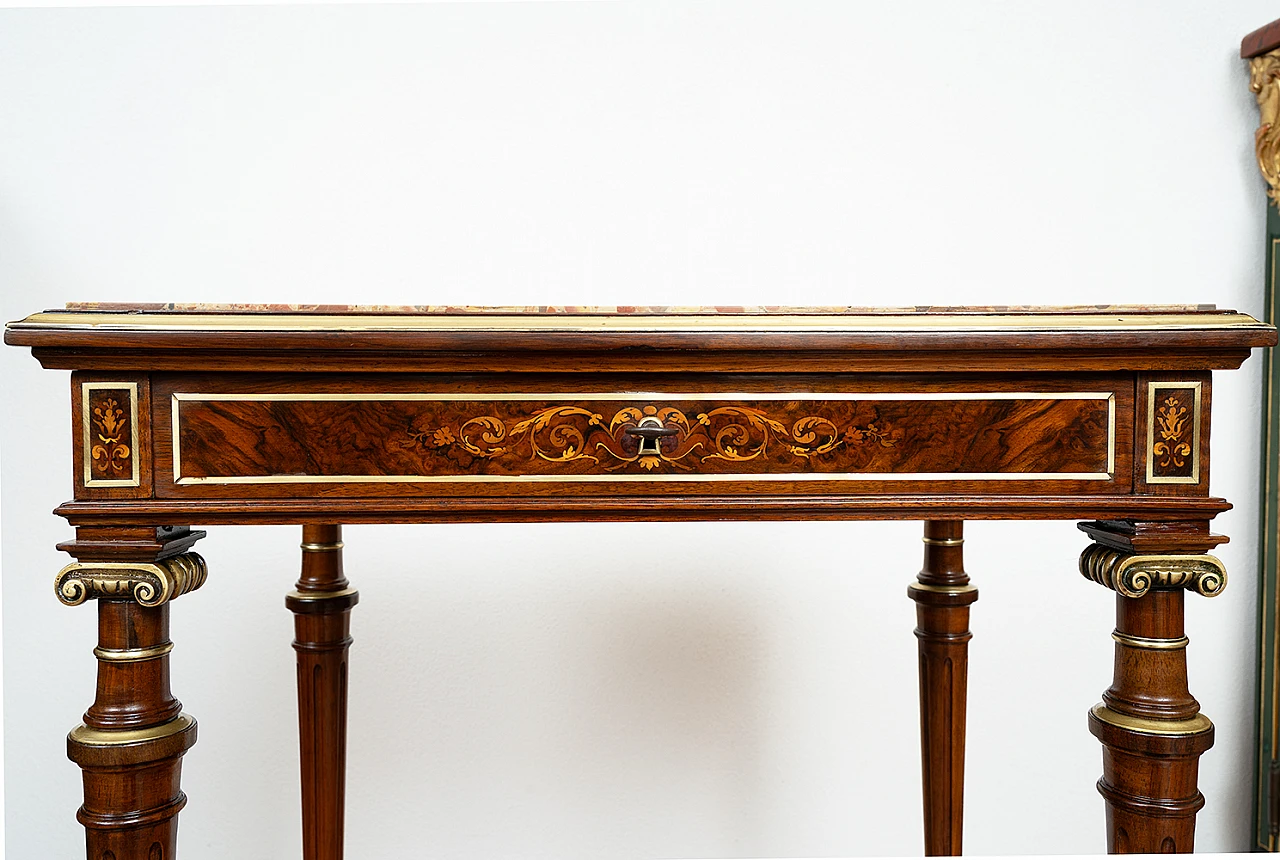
[906,521,978,856]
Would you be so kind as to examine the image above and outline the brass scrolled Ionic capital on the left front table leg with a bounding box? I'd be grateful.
[54,553,209,607]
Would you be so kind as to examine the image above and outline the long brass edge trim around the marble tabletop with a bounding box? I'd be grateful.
[15,311,1263,334]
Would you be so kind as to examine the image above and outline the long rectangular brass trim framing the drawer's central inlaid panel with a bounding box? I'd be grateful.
[170,392,1116,485]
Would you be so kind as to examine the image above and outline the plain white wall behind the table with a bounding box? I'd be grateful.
[0,0,1276,860]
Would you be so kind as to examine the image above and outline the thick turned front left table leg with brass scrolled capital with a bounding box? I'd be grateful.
[55,529,205,860]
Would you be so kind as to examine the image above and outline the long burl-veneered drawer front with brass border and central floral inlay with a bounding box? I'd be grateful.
[145,378,1134,495]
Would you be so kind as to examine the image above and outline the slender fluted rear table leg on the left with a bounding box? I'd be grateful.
[285,526,360,860]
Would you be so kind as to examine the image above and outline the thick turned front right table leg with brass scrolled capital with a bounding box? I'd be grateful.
[1080,526,1226,854]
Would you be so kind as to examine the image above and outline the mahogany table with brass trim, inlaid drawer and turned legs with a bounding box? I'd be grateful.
[5,305,1276,860]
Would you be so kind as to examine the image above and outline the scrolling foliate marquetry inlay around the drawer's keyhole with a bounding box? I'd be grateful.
[407,406,901,472]
